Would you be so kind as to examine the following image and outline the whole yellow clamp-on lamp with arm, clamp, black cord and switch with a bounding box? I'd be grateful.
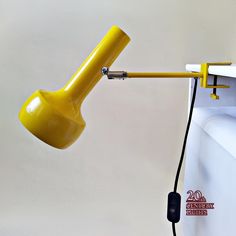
[19,26,231,235]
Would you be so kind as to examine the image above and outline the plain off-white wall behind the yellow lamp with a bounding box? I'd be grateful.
[0,0,236,236]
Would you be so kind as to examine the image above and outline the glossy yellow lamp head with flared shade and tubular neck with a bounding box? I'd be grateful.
[19,26,130,149]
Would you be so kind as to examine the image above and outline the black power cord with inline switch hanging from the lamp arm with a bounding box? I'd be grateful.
[167,78,198,236]
